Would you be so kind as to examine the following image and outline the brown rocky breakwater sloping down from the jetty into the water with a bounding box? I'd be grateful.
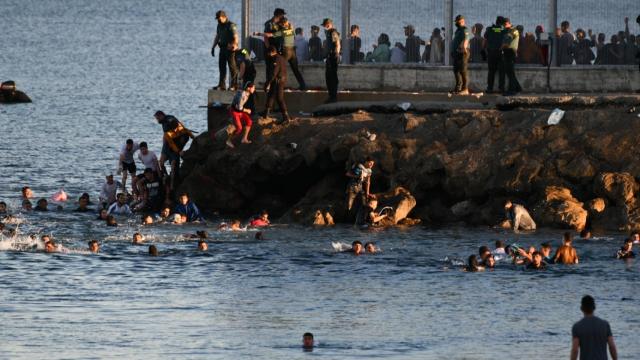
[181,96,640,230]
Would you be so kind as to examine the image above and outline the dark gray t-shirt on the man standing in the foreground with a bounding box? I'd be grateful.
[571,316,612,360]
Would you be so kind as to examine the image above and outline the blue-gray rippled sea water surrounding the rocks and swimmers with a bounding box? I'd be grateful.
[0,0,640,359]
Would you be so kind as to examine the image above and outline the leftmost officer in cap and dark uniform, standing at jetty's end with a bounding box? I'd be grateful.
[211,10,238,90]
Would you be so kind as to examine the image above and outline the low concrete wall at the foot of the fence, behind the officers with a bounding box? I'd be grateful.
[256,63,640,93]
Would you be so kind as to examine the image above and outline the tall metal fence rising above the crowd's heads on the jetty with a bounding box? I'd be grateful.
[241,0,640,64]
